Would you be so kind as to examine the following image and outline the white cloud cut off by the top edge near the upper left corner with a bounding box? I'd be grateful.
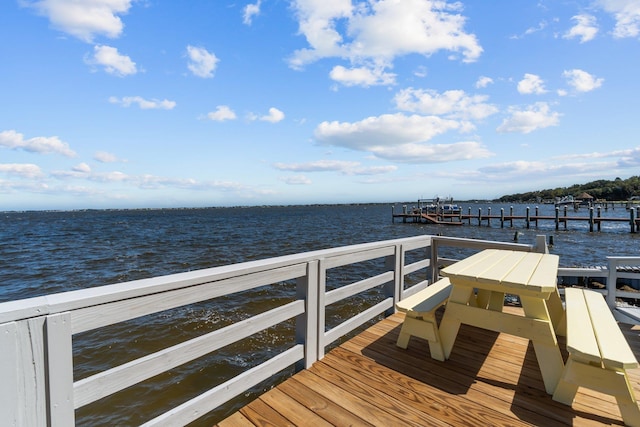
[20,0,131,43]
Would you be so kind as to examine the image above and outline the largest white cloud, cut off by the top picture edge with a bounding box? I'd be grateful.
[289,0,482,85]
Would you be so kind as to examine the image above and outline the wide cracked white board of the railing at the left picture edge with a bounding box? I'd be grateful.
[0,317,47,427]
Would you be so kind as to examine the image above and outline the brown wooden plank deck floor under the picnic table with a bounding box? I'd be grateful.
[218,307,640,427]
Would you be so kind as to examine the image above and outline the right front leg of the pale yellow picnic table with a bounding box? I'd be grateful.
[520,296,564,394]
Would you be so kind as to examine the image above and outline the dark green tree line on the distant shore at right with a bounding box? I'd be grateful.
[498,176,640,203]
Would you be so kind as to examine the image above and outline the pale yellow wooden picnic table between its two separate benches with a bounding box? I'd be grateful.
[439,249,564,394]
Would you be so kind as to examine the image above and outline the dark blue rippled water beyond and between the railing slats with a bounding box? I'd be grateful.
[0,203,640,426]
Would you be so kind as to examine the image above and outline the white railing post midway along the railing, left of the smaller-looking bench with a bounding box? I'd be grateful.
[296,260,324,369]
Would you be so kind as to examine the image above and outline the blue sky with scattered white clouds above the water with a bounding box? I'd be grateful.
[0,0,640,210]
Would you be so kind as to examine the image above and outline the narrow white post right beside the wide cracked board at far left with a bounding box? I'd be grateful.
[45,312,75,427]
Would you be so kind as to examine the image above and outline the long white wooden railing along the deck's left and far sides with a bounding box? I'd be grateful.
[0,236,546,427]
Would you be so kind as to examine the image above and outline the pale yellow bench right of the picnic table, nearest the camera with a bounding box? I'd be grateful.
[553,288,640,426]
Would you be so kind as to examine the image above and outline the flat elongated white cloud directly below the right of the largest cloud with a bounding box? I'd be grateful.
[394,88,498,119]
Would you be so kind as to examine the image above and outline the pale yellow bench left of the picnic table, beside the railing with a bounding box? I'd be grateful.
[396,278,451,361]
